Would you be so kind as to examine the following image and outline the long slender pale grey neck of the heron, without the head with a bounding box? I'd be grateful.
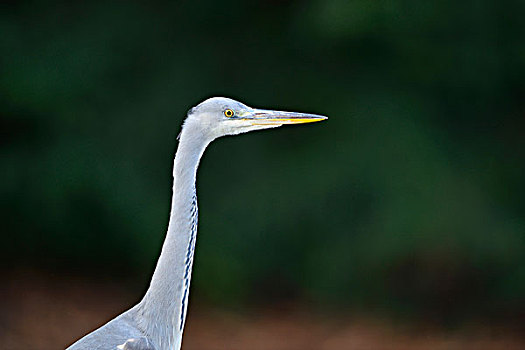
[138,127,211,350]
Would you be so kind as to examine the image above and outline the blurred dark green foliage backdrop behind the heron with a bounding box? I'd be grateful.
[0,0,525,318]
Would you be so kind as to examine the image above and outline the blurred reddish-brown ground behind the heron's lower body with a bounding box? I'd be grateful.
[0,273,525,350]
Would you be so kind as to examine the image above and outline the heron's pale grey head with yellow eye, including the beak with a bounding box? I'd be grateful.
[184,97,327,139]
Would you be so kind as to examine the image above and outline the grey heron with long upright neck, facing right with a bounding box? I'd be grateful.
[68,97,327,350]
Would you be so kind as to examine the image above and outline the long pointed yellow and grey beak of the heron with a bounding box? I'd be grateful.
[241,109,328,125]
